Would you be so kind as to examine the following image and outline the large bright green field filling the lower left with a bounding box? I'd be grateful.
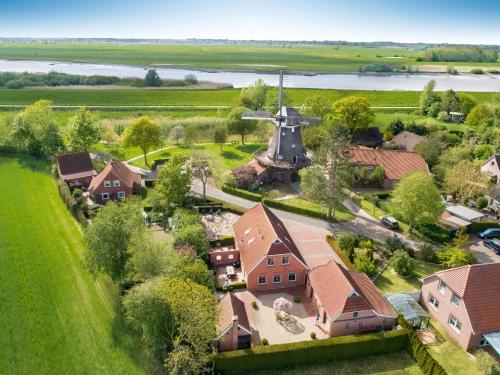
[0,155,151,374]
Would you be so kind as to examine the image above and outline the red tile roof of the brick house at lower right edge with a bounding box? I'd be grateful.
[424,263,500,334]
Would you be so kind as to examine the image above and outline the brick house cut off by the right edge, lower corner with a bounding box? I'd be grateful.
[421,263,500,355]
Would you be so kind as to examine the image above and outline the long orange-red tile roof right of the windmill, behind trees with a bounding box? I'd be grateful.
[351,147,429,180]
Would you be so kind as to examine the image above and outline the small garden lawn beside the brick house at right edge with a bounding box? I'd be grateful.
[375,261,444,295]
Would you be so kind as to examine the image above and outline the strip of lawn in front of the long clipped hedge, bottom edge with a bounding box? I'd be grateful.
[244,352,422,375]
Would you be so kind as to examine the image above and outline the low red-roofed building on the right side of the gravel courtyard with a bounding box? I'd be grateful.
[306,260,397,336]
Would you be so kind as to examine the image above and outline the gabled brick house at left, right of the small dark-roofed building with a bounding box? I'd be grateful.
[88,159,141,204]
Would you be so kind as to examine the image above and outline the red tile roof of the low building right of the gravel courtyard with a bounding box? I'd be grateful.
[309,260,397,317]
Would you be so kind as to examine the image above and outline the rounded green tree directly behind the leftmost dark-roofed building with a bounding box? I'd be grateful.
[68,107,101,151]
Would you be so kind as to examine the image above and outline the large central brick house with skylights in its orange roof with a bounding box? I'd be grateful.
[233,204,308,291]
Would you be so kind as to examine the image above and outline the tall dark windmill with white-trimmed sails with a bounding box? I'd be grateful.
[242,71,321,182]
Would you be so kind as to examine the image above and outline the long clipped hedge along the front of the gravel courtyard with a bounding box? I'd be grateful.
[215,329,408,374]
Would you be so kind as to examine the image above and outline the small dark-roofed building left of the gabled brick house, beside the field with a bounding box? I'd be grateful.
[56,151,97,189]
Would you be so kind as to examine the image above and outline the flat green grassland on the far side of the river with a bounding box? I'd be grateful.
[0,43,500,72]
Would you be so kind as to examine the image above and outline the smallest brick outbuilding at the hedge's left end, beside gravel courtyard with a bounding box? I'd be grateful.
[215,293,252,352]
